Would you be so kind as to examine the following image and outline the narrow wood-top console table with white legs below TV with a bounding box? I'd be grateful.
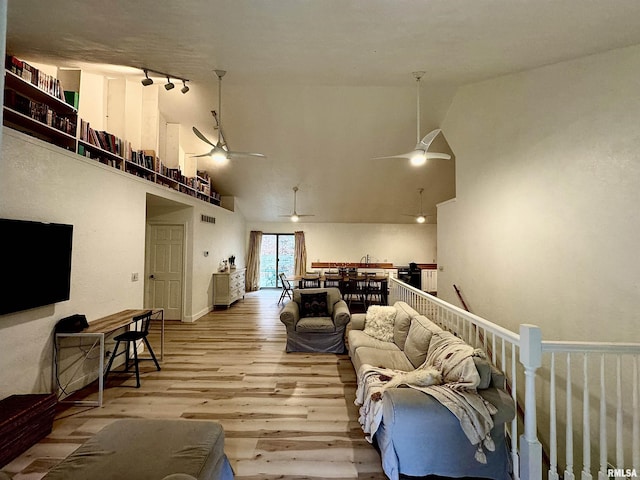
[53,308,164,407]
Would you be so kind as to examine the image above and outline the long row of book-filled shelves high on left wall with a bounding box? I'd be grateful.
[3,55,221,206]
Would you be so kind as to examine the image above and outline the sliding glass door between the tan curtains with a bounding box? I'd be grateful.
[260,233,295,288]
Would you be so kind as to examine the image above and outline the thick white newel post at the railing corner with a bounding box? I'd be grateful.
[520,324,542,480]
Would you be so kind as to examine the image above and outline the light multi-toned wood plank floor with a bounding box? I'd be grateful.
[2,290,386,480]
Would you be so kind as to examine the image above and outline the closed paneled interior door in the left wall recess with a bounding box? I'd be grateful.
[147,225,184,320]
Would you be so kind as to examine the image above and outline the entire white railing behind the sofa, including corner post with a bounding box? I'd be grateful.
[389,278,640,480]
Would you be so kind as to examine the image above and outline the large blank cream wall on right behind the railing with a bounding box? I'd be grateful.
[438,42,640,342]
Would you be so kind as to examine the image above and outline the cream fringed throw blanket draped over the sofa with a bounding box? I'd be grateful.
[355,340,497,463]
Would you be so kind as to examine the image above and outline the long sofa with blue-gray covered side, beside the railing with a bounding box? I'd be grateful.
[348,302,515,480]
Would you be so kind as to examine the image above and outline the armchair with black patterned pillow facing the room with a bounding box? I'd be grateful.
[280,288,351,353]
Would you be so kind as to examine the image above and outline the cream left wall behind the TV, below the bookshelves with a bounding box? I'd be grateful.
[0,128,245,398]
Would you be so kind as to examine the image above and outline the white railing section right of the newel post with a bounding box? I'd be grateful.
[541,341,640,480]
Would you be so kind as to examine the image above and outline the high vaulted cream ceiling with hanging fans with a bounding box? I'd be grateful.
[7,0,640,223]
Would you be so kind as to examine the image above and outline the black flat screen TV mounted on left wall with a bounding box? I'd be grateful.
[0,219,73,315]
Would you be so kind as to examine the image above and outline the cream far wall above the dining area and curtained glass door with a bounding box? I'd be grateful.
[247,222,437,268]
